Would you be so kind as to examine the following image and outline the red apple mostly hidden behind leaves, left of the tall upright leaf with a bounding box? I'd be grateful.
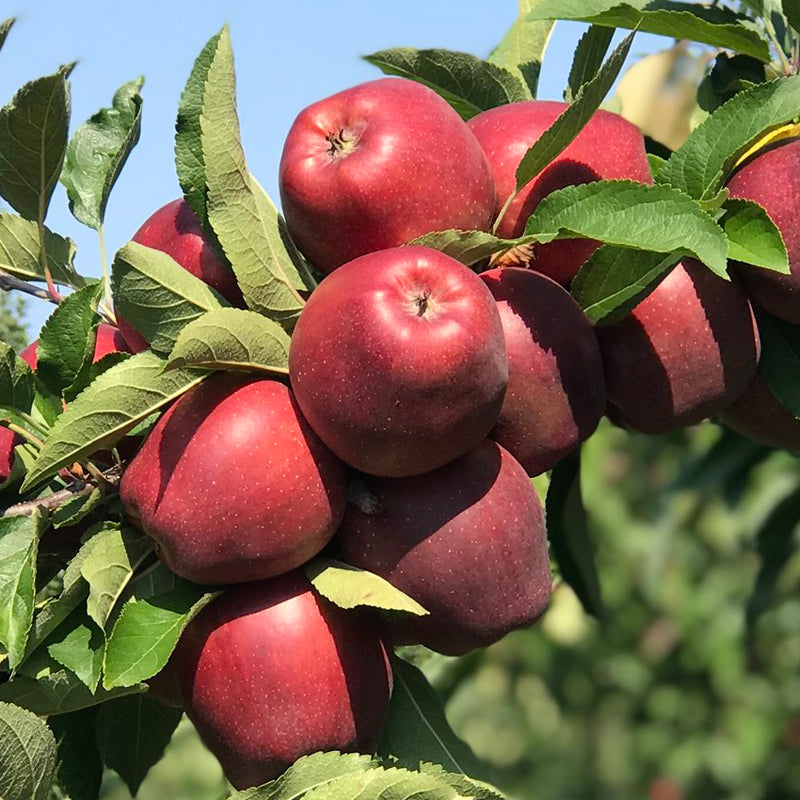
[117,198,244,346]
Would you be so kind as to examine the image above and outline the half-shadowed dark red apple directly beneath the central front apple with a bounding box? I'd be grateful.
[335,439,551,655]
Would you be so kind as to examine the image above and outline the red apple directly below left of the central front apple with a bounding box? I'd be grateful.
[120,373,346,584]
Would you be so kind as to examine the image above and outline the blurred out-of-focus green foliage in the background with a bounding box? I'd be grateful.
[15,43,800,800]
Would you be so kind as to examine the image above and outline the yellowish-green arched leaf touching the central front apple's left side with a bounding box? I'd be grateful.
[167,308,291,375]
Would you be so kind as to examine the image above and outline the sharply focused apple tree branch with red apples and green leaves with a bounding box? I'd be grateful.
[0,0,800,800]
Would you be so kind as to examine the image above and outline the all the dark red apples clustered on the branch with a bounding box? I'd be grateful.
[6,78,800,788]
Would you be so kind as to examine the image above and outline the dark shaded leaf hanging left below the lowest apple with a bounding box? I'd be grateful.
[95,695,183,795]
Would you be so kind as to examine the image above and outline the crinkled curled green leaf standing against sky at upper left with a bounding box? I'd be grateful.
[61,77,144,230]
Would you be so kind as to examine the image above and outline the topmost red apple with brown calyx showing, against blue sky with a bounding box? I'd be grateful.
[279,78,495,273]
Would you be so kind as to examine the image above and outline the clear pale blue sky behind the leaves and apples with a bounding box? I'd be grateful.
[0,0,666,336]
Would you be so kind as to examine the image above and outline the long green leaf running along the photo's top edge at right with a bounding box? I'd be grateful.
[527,0,770,61]
